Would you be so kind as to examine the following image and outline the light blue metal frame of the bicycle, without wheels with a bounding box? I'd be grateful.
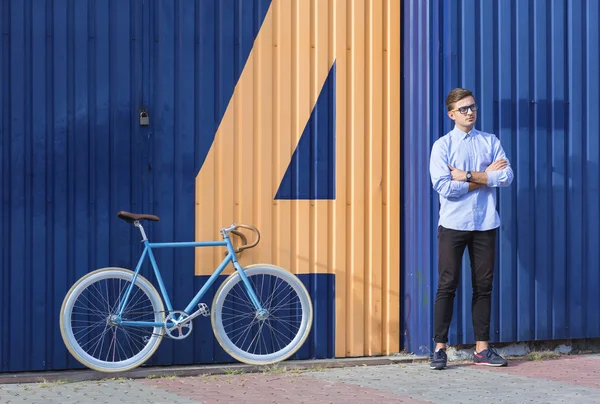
[114,222,264,327]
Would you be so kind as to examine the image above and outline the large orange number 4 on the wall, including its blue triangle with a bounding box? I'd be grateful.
[196,0,400,356]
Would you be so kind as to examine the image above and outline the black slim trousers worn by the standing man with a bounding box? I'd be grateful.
[434,226,496,343]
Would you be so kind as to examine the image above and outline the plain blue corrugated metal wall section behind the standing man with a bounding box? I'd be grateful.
[402,0,600,354]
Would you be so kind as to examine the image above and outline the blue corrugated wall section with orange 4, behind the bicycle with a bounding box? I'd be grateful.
[0,0,400,371]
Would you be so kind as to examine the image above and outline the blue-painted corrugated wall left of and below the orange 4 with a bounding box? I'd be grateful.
[0,0,335,372]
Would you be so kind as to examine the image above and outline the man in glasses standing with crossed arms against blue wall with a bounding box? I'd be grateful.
[430,88,513,370]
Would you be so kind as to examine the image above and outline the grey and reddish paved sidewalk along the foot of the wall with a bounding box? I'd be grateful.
[0,355,600,404]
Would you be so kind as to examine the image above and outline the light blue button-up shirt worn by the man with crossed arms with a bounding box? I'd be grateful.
[429,127,514,230]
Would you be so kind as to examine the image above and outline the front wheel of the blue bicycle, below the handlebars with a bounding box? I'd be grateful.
[211,264,313,365]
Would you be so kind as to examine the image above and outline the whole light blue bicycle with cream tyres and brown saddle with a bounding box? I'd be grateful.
[60,211,313,372]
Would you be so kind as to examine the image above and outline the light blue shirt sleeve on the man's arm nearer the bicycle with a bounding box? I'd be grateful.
[429,141,469,199]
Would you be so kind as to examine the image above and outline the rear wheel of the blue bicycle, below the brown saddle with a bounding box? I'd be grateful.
[60,268,165,372]
